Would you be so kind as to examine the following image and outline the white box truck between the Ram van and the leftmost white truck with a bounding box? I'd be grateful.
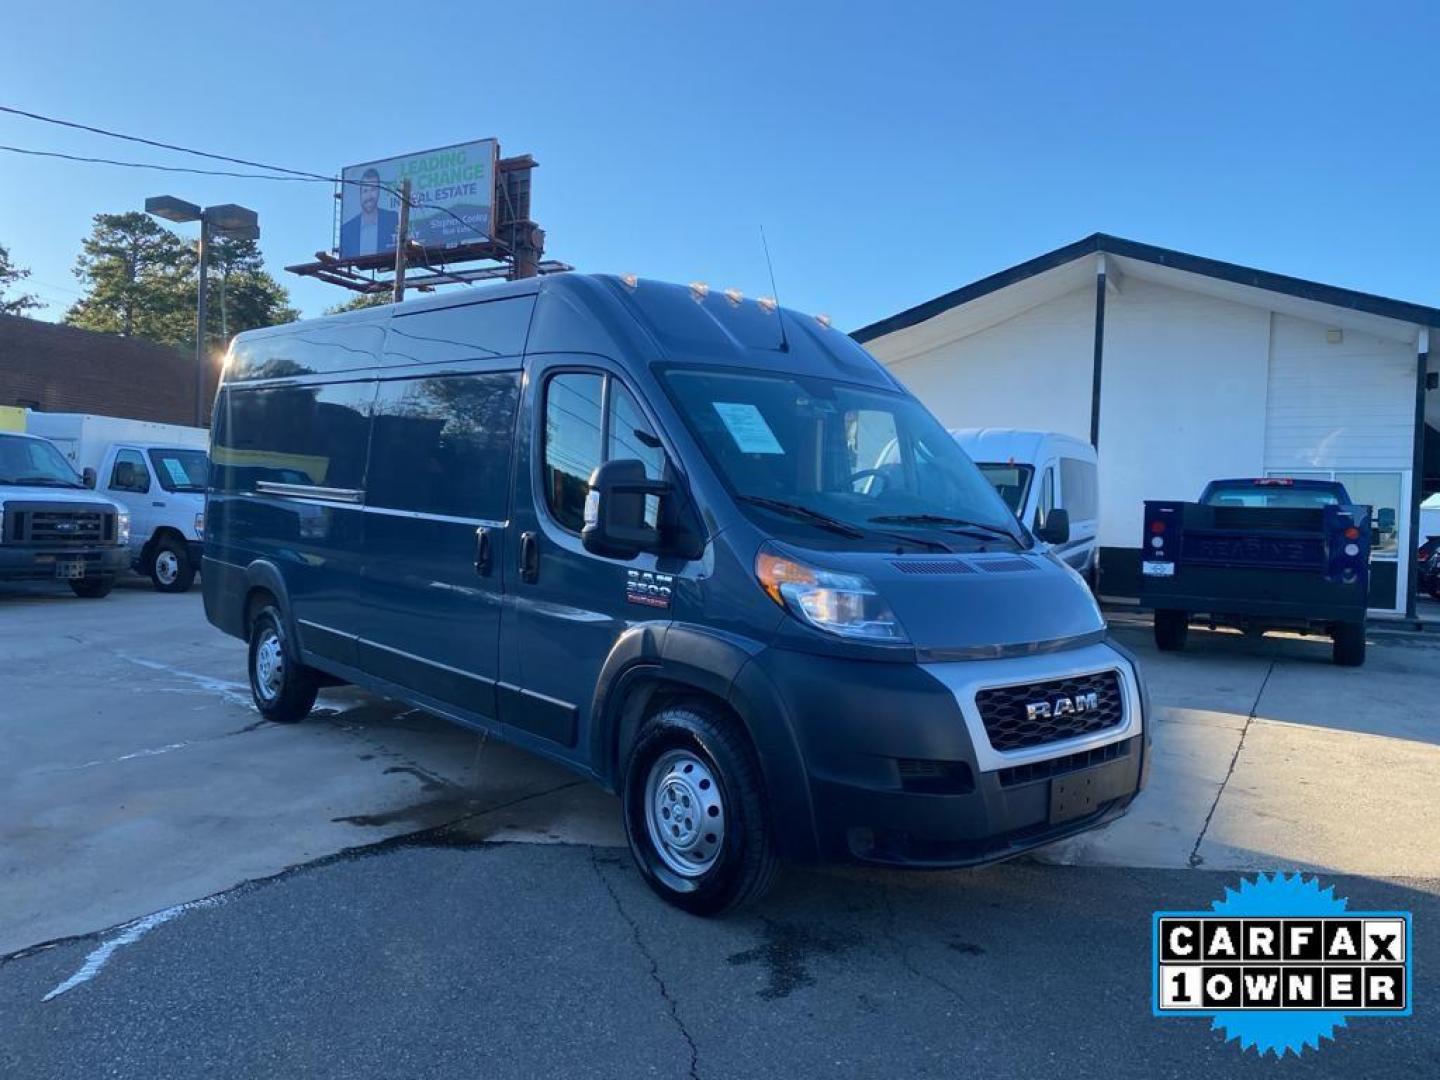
[27,412,210,592]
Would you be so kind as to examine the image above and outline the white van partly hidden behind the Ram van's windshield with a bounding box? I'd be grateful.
[950,428,1100,580]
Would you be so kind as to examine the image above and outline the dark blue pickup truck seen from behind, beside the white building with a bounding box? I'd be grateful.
[1140,477,1371,667]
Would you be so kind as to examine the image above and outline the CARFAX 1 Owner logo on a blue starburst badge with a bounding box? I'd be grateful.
[1151,874,1413,1057]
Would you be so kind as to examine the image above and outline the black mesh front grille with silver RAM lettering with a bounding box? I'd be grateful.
[975,671,1125,750]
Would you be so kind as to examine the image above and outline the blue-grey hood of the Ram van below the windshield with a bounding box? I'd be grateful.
[814,550,1104,660]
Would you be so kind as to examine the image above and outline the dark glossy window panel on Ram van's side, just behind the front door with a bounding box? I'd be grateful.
[366,372,520,521]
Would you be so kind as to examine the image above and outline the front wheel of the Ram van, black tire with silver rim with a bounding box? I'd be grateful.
[622,701,779,914]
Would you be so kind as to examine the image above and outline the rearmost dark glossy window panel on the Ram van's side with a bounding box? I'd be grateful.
[210,382,374,492]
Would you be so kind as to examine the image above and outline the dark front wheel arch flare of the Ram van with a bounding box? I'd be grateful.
[590,624,819,861]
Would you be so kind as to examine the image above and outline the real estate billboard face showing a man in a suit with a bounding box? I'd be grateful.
[338,138,500,259]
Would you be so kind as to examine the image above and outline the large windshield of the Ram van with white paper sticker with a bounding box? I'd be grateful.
[664,369,1030,547]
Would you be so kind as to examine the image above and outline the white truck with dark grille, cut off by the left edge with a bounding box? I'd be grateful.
[0,431,130,598]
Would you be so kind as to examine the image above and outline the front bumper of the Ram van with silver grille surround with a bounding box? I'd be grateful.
[756,645,1149,868]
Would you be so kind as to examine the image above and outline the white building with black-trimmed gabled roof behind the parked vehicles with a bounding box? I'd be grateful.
[854,233,1440,615]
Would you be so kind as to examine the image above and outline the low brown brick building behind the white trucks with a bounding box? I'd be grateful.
[0,315,219,423]
